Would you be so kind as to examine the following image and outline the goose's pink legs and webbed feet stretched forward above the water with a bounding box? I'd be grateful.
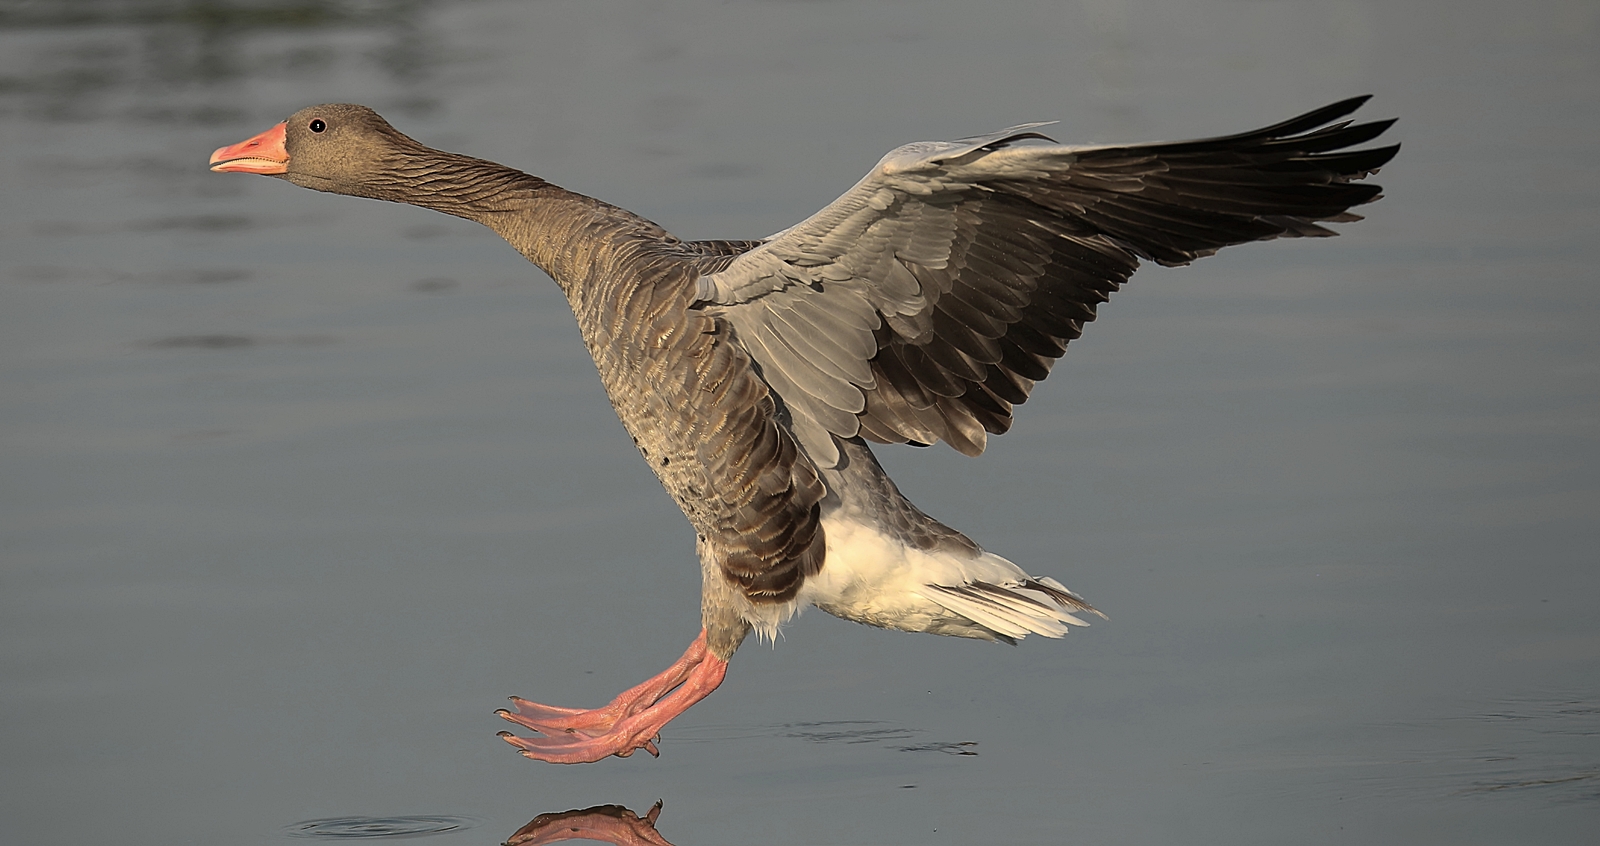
[494,630,728,764]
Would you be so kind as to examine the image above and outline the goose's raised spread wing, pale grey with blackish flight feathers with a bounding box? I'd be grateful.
[696,98,1398,467]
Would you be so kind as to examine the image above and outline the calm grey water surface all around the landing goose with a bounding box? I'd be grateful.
[0,0,1600,846]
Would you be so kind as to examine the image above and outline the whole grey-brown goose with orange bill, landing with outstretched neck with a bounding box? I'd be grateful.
[211,96,1398,763]
